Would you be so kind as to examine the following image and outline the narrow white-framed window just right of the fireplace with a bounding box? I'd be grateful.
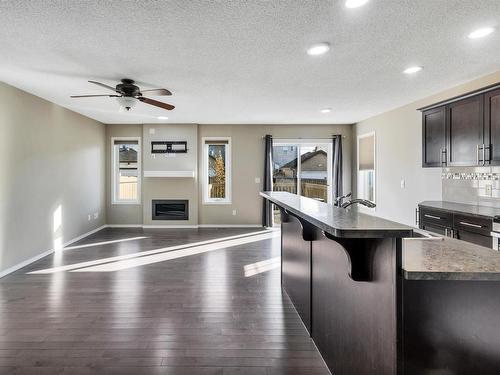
[203,137,231,204]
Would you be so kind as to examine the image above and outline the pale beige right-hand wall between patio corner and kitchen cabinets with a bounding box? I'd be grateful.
[353,72,500,225]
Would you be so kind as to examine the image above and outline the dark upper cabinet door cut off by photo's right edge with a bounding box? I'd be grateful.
[484,89,500,165]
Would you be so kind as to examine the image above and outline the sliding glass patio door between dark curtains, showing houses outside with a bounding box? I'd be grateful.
[273,143,331,223]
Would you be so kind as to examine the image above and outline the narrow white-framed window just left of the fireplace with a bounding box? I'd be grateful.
[111,137,141,204]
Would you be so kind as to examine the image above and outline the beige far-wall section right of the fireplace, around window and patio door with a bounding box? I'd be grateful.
[198,125,352,225]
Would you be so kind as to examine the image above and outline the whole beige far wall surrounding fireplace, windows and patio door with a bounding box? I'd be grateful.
[106,124,352,225]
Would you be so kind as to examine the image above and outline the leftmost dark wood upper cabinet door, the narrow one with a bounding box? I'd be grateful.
[422,107,446,167]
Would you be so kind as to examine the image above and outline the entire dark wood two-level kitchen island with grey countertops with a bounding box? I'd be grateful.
[261,192,500,375]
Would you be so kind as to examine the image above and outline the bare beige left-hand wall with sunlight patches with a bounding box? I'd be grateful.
[0,83,106,274]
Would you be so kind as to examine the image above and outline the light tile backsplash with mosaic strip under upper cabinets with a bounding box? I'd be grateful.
[441,167,500,208]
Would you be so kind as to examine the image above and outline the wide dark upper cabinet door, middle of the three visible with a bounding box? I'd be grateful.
[446,95,485,166]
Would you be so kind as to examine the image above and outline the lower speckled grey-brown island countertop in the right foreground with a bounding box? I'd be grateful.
[403,237,500,281]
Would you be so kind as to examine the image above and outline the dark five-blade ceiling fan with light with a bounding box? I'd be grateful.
[71,78,175,111]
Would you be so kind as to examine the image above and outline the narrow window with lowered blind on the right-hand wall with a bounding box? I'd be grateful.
[357,132,376,203]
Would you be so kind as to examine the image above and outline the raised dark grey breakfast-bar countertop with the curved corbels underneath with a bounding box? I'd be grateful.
[260,191,413,238]
